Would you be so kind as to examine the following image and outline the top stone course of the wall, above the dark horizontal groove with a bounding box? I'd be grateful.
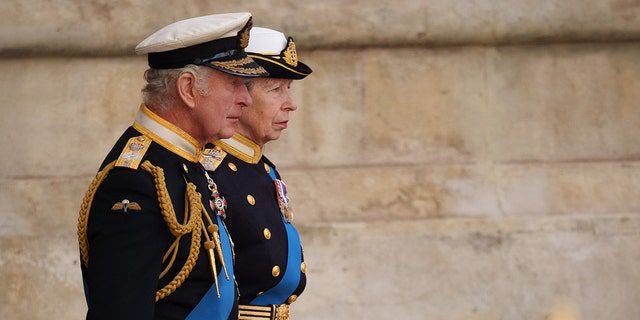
[0,0,640,55]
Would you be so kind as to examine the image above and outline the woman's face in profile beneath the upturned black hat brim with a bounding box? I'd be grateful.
[238,78,297,146]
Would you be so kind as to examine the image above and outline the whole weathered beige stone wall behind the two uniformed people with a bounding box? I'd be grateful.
[0,0,640,320]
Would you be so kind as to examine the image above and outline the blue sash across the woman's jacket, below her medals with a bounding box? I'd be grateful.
[251,167,302,306]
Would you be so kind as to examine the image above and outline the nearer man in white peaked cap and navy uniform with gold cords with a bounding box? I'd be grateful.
[78,13,267,319]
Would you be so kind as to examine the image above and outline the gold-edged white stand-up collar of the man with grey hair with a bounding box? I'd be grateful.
[133,105,202,162]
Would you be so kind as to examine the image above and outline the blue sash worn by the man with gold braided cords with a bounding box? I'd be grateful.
[187,215,236,320]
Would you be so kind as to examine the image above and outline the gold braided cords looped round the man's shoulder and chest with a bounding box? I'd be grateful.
[78,161,207,301]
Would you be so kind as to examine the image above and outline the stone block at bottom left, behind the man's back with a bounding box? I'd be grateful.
[0,232,87,320]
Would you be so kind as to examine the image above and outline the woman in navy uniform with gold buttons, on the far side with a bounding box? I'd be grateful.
[203,27,311,319]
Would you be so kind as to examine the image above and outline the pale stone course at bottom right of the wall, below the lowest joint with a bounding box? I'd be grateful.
[293,215,640,320]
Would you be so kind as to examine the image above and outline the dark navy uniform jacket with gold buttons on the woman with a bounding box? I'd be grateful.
[205,133,306,305]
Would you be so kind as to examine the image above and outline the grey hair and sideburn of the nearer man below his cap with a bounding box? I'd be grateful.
[142,64,212,112]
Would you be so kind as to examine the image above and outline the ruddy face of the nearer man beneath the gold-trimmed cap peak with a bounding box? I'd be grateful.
[193,70,252,142]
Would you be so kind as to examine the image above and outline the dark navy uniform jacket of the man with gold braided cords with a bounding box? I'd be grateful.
[78,106,237,319]
